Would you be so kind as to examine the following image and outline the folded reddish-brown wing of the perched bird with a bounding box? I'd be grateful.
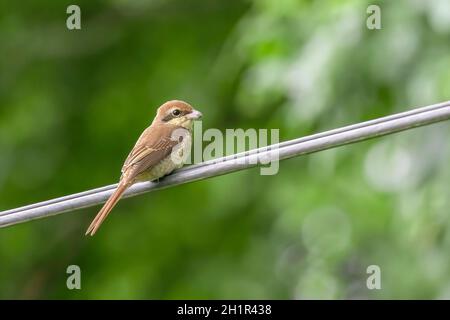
[122,125,182,179]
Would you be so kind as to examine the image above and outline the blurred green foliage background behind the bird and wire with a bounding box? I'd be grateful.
[0,0,450,299]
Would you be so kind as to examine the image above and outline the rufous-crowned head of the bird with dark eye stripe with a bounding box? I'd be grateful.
[153,100,202,130]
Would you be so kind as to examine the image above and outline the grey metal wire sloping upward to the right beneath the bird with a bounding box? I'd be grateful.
[0,101,450,227]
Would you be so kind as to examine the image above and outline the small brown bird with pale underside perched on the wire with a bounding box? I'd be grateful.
[86,100,202,236]
